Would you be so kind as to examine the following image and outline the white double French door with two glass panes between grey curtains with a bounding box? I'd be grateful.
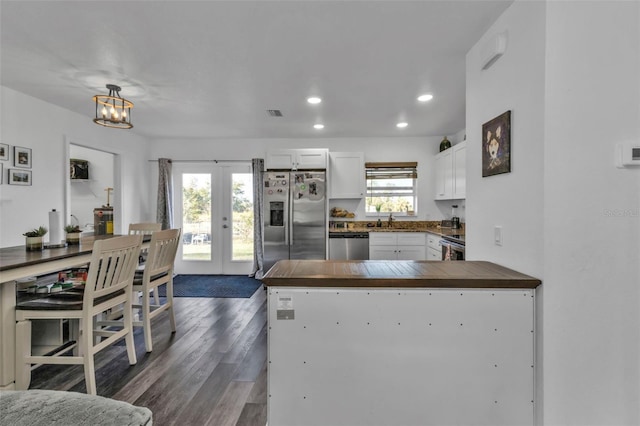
[173,162,253,275]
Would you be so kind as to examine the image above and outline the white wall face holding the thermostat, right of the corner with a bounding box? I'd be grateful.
[542,2,640,425]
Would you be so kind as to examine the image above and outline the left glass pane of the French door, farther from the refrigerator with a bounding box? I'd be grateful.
[182,173,211,260]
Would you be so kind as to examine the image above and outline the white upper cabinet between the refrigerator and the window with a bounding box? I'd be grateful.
[329,152,366,198]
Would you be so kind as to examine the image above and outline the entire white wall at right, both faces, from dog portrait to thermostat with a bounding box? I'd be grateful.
[466,1,640,425]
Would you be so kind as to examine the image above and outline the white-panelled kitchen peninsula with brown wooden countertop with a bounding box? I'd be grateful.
[262,260,540,425]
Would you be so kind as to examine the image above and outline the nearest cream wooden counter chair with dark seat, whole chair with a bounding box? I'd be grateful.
[15,235,142,395]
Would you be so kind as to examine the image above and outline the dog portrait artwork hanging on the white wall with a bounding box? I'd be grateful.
[482,111,511,177]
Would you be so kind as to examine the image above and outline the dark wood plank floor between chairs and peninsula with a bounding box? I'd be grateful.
[30,286,267,426]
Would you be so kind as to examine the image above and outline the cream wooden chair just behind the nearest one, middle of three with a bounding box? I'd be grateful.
[133,229,181,352]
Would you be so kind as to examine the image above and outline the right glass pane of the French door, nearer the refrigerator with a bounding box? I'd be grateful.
[231,173,253,261]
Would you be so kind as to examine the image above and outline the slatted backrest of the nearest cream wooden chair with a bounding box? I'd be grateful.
[84,235,142,307]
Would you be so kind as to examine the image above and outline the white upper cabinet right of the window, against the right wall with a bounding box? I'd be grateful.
[435,141,467,200]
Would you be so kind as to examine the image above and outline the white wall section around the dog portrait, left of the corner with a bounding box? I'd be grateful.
[466,2,545,277]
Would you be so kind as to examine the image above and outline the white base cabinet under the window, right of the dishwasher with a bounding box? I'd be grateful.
[369,232,427,260]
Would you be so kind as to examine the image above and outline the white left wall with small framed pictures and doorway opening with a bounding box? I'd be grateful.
[0,86,150,247]
